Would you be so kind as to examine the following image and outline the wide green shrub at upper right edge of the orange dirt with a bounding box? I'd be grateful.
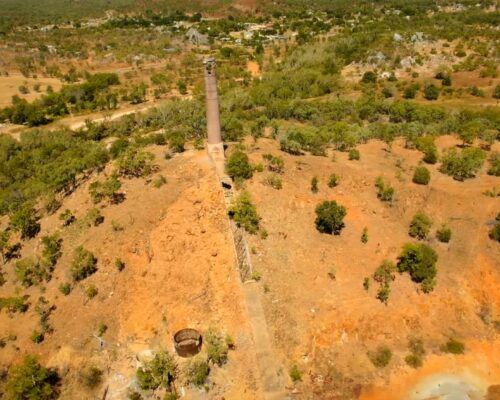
[439,147,485,181]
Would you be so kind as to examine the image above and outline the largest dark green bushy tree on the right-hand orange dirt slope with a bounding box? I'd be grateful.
[397,243,438,292]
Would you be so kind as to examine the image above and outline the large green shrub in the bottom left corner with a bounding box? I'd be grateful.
[5,356,59,400]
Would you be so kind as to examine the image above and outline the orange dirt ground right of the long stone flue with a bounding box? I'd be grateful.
[240,137,500,400]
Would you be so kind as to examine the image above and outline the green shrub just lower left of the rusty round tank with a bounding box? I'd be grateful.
[136,351,177,390]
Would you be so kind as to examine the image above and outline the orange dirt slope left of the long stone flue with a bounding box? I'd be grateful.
[0,147,260,399]
